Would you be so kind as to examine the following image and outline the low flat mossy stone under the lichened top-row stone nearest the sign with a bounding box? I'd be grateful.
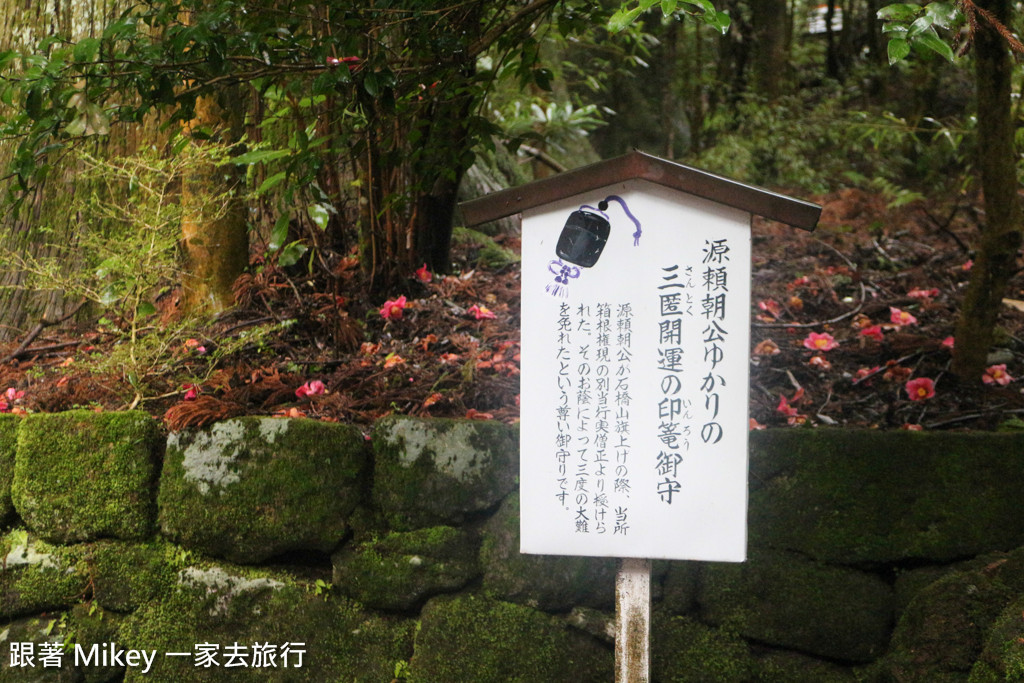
[333,526,479,610]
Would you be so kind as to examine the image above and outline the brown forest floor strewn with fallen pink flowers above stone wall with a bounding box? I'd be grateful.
[0,190,1024,430]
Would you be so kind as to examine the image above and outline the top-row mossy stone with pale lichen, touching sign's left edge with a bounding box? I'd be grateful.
[373,417,519,530]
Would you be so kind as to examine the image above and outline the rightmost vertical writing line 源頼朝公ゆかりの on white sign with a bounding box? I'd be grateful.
[700,240,729,444]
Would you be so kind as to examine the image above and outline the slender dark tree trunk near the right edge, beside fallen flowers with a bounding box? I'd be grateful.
[952,0,1021,382]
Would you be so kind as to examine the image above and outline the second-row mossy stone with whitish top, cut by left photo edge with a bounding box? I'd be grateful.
[0,529,89,618]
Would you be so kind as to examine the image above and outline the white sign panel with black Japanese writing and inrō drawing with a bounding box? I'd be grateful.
[520,180,751,561]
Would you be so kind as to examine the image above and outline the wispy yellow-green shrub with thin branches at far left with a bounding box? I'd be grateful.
[0,143,229,400]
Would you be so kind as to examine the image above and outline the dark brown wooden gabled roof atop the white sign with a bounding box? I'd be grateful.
[462,152,821,230]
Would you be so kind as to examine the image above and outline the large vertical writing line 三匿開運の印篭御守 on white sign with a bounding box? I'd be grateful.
[654,264,693,505]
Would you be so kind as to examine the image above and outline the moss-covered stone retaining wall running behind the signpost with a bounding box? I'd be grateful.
[0,411,1024,683]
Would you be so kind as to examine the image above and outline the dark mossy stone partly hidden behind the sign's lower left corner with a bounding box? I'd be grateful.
[480,494,617,611]
